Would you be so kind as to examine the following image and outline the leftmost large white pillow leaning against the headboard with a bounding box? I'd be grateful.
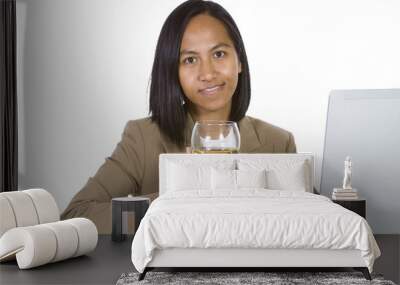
[167,162,211,191]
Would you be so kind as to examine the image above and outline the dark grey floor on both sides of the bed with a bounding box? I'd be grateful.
[0,235,400,285]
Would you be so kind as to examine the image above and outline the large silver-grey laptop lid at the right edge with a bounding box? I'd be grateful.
[320,89,400,234]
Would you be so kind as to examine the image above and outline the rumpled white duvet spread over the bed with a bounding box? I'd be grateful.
[132,189,380,272]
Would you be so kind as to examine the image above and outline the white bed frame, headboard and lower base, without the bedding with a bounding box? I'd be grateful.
[139,153,371,280]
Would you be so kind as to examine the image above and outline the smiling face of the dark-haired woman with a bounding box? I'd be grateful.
[179,14,241,119]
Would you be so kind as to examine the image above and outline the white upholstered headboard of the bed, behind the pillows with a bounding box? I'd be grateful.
[159,153,314,195]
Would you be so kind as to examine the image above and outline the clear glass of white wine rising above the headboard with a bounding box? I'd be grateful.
[191,120,240,154]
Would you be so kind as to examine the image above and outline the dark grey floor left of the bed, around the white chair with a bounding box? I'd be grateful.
[0,235,135,285]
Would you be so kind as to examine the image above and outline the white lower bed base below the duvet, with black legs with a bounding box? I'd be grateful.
[139,248,371,280]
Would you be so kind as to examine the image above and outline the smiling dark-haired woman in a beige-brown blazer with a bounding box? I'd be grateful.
[62,0,296,233]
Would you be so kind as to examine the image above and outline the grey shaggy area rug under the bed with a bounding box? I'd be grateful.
[117,271,395,285]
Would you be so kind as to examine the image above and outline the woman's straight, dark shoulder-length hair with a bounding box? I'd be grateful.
[149,0,250,146]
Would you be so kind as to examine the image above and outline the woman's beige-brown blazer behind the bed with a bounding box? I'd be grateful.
[61,115,296,234]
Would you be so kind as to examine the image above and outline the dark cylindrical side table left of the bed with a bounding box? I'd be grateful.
[111,196,150,241]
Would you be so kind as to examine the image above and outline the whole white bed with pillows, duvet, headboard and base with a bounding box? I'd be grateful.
[132,154,380,280]
